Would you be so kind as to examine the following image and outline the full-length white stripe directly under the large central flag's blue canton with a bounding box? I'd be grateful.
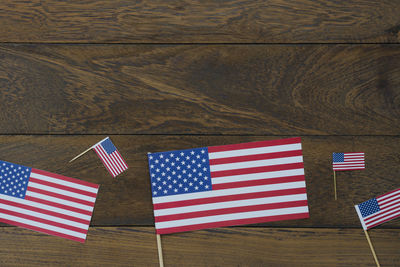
[153,181,306,204]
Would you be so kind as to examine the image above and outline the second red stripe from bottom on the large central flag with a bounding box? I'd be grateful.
[154,200,307,222]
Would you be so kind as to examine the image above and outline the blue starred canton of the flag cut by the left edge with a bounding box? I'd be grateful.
[0,160,32,198]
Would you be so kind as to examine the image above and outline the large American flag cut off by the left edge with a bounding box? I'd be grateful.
[0,160,99,243]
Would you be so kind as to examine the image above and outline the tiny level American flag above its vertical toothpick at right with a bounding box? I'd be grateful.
[333,152,365,171]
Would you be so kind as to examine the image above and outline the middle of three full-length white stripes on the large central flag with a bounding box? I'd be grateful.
[154,193,307,217]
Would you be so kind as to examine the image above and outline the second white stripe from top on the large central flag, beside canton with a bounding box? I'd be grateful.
[210,156,303,172]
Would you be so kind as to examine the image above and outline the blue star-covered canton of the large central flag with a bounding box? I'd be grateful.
[148,147,212,197]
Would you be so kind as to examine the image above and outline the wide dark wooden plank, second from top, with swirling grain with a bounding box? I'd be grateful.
[0,45,400,135]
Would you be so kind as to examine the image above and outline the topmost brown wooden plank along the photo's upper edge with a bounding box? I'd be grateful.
[0,0,400,43]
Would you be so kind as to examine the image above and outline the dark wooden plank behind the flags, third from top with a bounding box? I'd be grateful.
[0,136,400,228]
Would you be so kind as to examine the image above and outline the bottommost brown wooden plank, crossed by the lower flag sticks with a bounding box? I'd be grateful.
[0,227,400,266]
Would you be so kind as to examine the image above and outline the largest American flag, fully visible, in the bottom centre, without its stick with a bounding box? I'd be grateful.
[148,138,309,234]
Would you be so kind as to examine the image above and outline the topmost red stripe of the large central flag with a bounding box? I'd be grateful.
[208,137,301,153]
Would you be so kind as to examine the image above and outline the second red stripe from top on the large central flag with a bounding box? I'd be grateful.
[210,150,302,165]
